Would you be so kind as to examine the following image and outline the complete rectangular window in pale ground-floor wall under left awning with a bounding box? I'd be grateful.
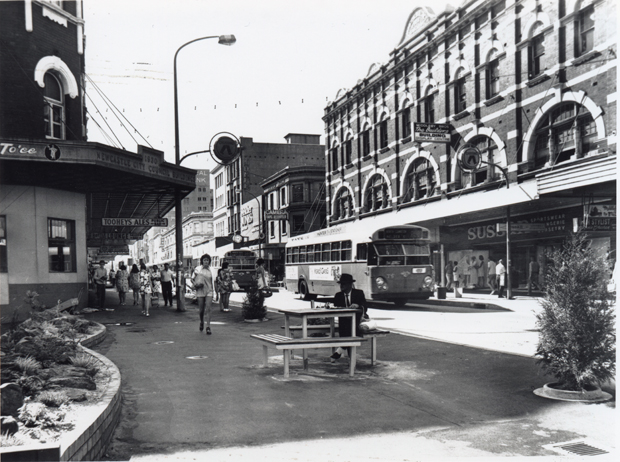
[47,218,76,273]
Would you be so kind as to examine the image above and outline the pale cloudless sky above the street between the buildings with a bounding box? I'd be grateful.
[84,0,450,169]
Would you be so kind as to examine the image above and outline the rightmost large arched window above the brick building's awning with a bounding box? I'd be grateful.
[534,102,598,168]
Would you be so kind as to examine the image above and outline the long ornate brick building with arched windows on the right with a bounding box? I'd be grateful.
[324,0,617,284]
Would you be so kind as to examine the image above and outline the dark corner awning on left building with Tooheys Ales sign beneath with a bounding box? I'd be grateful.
[0,140,196,253]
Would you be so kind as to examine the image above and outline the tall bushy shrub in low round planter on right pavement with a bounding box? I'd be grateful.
[535,232,616,401]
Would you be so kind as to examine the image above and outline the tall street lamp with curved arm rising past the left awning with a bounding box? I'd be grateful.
[174,35,237,311]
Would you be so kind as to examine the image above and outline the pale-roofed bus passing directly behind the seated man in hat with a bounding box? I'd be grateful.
[285,223,435,304]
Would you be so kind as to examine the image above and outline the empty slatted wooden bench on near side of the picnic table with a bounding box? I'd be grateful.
[251,334,366,377]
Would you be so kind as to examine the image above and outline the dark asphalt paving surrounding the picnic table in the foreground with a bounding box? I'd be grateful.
[87,290,616,460]
